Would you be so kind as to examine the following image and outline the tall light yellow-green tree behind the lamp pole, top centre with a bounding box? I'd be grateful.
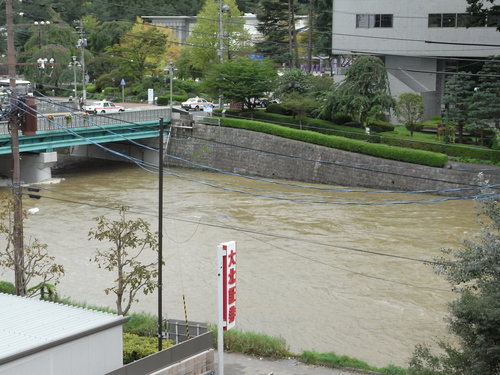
[182,0,252,72]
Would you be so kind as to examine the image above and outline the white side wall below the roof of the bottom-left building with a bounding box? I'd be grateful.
[0,325,123,375]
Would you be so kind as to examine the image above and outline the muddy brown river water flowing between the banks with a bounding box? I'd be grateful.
[0,164,477,366]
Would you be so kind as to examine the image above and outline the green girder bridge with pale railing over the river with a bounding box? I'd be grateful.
[0,108,170,155]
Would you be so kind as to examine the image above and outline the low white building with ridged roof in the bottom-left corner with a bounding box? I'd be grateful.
[0,293,128,375]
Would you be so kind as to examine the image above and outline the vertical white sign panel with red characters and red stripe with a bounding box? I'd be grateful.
[218,241,236,330]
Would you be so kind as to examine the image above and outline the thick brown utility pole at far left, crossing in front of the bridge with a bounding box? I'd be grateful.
[5,0,26,296]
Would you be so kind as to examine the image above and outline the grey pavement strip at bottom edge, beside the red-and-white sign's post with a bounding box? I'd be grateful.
[215,352,366,375]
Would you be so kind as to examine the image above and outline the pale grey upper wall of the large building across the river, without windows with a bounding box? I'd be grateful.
[333,0,500,57]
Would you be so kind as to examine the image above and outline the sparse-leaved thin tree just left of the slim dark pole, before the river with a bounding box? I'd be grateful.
[89,207,158,315]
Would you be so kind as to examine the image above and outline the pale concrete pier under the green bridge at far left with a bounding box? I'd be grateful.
[0,151,57,184]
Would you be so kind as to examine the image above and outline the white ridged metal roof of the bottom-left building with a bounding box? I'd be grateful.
[0,293,127,363]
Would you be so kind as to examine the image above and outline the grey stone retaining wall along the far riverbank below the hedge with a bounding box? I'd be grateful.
[167,124,500,195]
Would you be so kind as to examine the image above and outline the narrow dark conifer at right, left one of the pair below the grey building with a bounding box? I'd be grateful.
[443,72,474,142]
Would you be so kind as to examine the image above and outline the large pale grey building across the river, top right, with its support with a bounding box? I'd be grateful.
[332,0,500,117]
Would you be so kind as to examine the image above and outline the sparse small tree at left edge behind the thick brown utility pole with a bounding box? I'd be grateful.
[0,197,64,299]
